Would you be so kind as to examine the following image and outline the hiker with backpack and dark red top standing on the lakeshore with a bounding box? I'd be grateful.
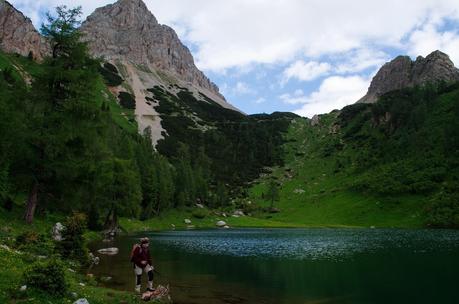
[131,237,154,292]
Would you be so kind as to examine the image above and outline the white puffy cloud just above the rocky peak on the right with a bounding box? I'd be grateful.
[409,22,459,66]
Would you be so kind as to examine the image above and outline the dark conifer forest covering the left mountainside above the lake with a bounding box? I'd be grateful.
[0,8,292,229]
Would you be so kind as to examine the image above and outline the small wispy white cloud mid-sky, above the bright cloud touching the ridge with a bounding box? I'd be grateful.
[281,60,332,84]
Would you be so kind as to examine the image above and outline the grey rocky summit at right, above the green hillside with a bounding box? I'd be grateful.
[358,51,459,103]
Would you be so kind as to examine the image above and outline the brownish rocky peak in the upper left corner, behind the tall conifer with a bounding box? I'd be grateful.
[0,0,49,60]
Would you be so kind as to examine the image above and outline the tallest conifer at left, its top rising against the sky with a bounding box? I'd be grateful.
[25,6,100,223]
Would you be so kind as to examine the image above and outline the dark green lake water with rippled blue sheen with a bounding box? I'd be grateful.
[92,229,459,304]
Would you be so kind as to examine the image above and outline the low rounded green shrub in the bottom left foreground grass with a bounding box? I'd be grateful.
[23,260,68,296]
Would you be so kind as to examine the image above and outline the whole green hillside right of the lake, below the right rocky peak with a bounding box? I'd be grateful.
[250,84,459,227]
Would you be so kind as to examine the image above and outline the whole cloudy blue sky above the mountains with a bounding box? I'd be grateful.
[10,0,459,117]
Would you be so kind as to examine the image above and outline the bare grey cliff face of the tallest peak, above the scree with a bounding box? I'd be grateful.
[81,0,228,102]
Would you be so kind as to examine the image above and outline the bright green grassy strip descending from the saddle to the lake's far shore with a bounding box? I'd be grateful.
[250,119,421,227]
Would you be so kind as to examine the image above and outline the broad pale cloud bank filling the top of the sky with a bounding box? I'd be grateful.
[147,0,459,72]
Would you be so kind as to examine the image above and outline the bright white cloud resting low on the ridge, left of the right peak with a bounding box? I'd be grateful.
[292,76,370,117]
